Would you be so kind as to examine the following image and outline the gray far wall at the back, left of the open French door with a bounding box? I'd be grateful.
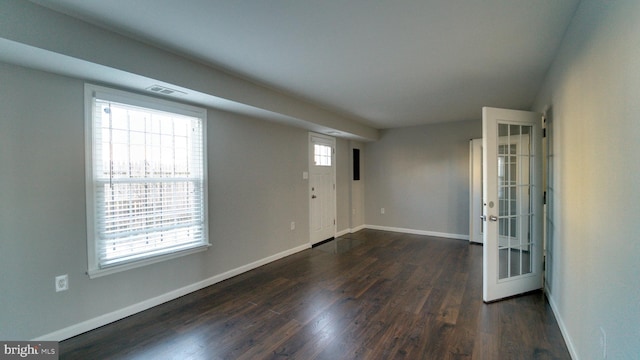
[365,121,482,237]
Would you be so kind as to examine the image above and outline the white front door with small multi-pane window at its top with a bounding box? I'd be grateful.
[309,134,336,245]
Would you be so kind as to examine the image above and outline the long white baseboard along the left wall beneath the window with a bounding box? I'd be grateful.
[33,244,311,341]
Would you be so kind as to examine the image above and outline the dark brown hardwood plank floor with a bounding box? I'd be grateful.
[60,230,570,359]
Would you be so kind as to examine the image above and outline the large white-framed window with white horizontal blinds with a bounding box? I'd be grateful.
[85,85,209,277]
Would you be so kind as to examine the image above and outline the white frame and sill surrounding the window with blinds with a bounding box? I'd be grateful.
[84,84,211,278]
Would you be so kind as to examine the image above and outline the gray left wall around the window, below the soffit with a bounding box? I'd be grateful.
[0,63,351,340]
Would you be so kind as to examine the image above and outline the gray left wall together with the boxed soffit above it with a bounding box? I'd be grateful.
[0,0,370,340]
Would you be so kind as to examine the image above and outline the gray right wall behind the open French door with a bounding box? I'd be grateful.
[535,0,640,359]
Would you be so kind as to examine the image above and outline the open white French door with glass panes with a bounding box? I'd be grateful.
[482,107,543,302]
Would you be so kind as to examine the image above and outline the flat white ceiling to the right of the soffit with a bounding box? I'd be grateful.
[32,0,579,129]
